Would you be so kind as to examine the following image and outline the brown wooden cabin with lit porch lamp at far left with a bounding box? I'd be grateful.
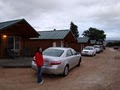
[0,19,39,58]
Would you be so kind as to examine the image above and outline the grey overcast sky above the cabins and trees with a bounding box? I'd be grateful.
[0,0,120,40]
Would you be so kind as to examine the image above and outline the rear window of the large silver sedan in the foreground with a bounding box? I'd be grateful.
[43,49,64,57]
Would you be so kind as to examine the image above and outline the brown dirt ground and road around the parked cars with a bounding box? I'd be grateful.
[0,48,120,90]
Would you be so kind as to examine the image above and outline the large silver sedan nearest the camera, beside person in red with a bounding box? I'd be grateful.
[32,47,81,76]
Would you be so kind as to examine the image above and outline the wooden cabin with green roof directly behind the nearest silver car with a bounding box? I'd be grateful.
[26,30,76,55]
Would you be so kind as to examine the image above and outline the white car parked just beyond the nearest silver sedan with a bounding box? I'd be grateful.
[81,46,96,56]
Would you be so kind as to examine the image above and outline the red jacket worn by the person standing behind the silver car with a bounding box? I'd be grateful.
[35,52,44,67]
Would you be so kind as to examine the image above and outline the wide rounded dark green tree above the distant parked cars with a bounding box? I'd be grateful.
[82,27,106,42]
